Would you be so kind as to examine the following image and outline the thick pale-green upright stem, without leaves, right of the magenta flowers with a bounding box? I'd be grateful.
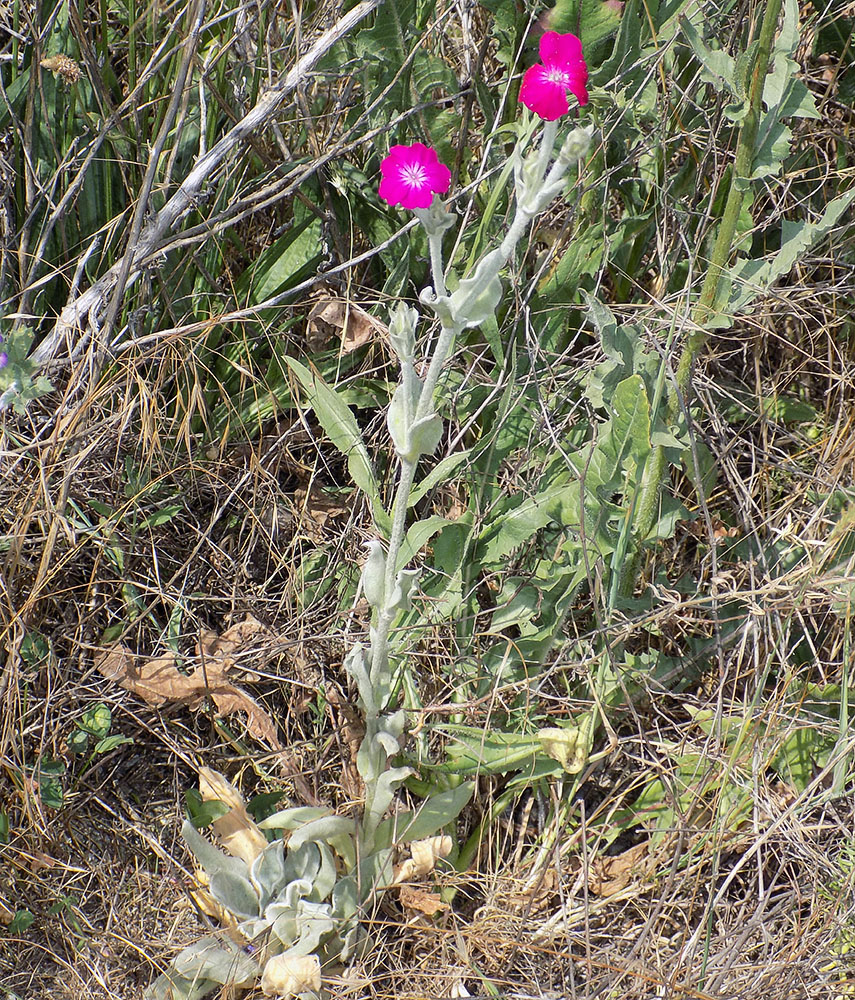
[620,0,782,596]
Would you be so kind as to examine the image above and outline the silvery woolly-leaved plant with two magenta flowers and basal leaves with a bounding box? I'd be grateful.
[146,32,591,1000]
